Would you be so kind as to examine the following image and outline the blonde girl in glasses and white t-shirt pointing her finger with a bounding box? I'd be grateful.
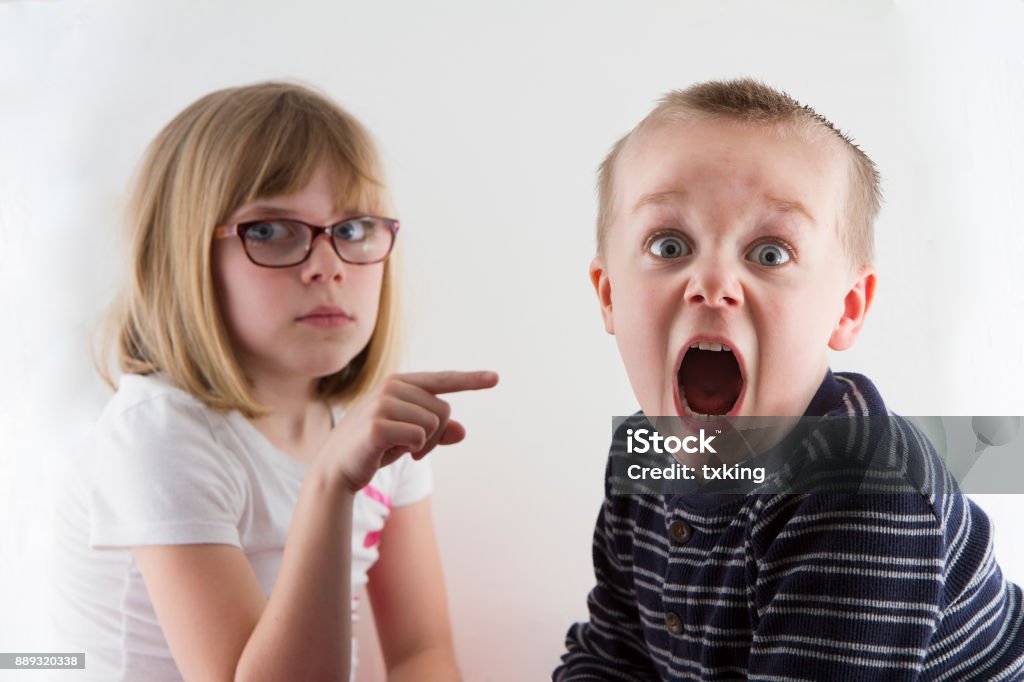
[50,83,497,680]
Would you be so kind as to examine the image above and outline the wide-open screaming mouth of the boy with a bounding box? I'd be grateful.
[676,341,743,417]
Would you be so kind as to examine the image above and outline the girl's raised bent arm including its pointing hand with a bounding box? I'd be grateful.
[132,372,497,682]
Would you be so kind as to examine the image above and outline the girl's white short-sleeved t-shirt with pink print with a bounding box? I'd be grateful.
[51,375,432,681]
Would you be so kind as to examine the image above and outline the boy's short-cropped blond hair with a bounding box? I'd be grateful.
[597,79,882,268]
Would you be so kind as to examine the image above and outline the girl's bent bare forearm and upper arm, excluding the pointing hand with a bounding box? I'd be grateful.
[133,462,353,681]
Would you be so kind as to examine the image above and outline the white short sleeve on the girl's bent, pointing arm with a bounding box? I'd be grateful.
[89,394,244,549]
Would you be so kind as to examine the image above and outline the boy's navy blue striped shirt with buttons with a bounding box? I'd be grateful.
[553,372,1024,682]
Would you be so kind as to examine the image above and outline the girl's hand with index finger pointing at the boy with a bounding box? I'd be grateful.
[319,372,498,494]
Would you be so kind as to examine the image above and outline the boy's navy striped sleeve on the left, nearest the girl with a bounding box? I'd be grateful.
[552,460,658,682]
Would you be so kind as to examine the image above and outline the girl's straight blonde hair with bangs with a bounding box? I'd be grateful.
[98,83,398,418]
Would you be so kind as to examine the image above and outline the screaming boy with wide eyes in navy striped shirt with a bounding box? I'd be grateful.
[554,80,1024,682]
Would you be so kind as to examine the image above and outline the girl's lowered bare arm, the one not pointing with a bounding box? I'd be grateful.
[367,498,460,682]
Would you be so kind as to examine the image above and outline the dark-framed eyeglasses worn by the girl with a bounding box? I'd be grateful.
[213,215,398,267]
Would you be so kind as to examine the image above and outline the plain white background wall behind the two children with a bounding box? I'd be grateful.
[0,0,1024,680]
